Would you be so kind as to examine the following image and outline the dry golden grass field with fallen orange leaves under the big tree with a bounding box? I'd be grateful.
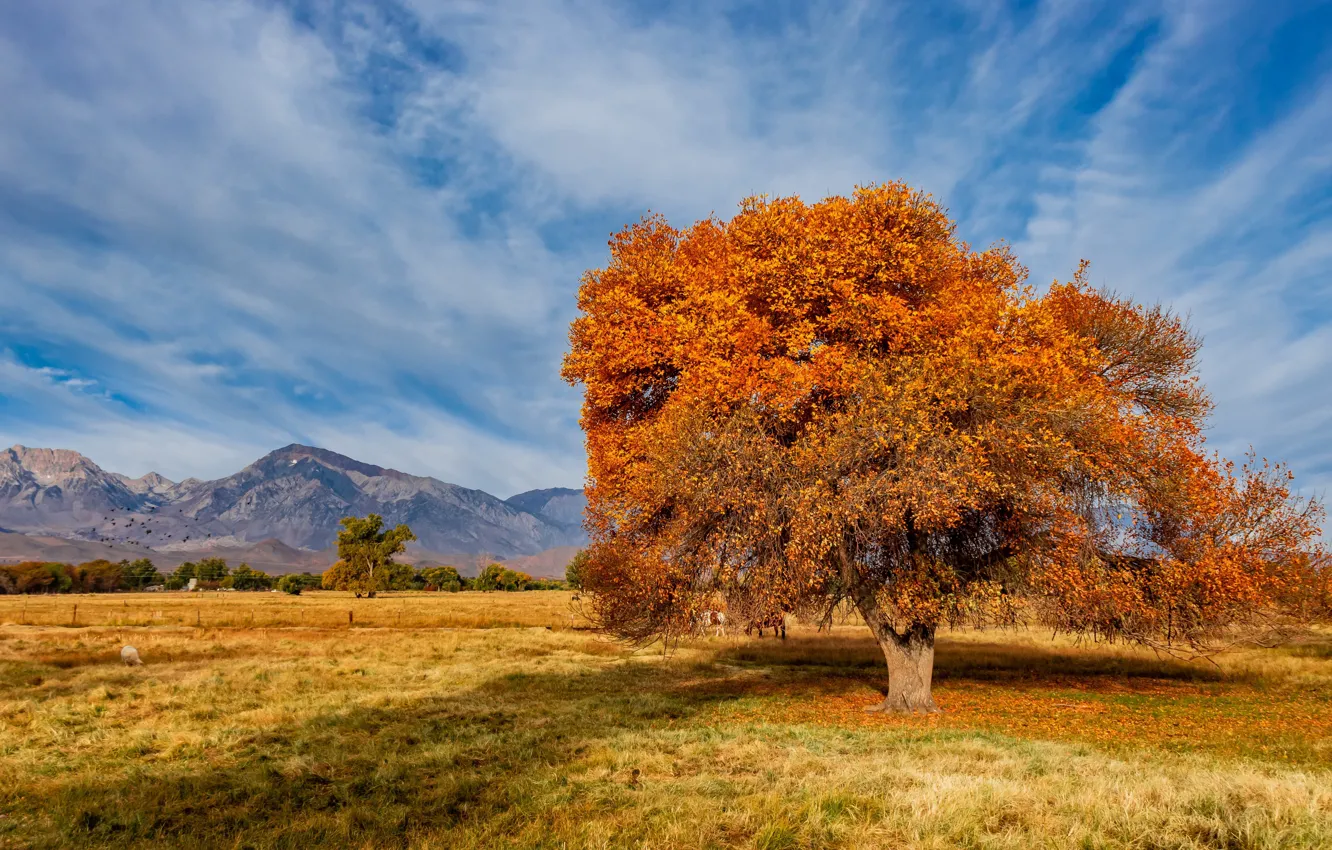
[0,592,1332,850]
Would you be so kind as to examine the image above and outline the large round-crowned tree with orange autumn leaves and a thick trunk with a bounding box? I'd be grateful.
[563,184,1324,711]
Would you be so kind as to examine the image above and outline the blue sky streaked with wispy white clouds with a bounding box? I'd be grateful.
[0,0,1332,506]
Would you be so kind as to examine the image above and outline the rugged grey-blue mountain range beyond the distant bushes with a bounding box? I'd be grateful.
[0,444,586,572]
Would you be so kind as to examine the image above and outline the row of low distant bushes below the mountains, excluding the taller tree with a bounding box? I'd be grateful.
[0,558,569,594]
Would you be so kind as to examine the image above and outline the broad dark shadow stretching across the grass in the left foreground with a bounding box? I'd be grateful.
[0,663,772,847]
